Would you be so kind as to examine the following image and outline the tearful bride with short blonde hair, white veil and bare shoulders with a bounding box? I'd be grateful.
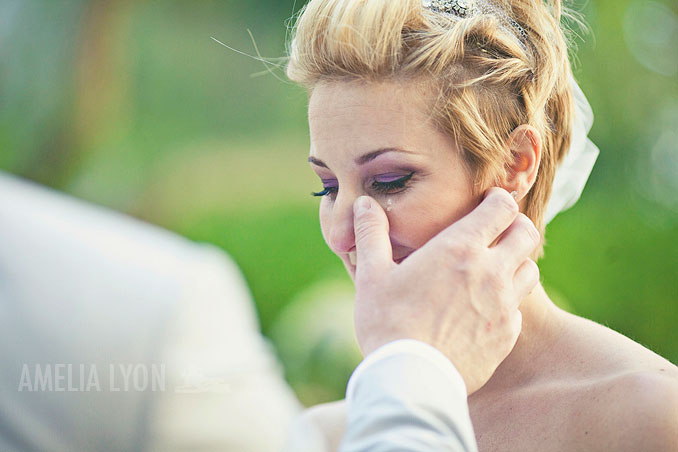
[287,0,678,451]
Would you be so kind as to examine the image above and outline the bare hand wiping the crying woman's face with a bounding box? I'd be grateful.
[353,188,540,394]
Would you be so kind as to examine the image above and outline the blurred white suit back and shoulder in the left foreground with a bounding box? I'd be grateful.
[0,171,301,452]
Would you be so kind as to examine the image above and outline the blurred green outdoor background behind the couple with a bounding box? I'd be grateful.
[0,0,678,404]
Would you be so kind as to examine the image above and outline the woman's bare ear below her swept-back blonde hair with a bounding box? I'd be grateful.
[504,124,541,200]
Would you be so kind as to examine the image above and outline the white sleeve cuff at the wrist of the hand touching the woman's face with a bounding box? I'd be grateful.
[339,340,477,452]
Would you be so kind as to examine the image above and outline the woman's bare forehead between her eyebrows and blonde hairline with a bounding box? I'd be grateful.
[308,82,435,155]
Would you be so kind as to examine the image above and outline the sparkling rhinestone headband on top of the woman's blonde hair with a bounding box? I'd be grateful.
[422,0,527,48]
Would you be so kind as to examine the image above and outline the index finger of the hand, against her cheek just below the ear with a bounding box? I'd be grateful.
[448,187,519,247]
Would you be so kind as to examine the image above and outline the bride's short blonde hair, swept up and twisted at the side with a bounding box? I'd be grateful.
[287,0,574,257]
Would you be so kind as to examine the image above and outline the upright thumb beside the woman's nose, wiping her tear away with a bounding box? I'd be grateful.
[353,196,393,279]
